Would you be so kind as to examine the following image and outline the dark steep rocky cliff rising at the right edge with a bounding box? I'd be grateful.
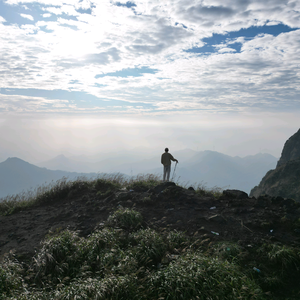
[250,129,300,201]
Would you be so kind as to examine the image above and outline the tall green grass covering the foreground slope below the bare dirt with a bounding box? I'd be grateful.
[0,205,299,300]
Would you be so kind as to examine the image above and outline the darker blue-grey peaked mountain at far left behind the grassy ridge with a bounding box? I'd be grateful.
[0,157,96,197]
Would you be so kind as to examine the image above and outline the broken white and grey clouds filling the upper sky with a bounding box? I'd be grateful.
[0,0,300,115]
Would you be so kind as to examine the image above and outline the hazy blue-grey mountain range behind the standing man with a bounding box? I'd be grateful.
[0,149,277,201]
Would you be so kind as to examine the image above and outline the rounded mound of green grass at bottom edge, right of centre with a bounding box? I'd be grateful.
[143,253,263,300]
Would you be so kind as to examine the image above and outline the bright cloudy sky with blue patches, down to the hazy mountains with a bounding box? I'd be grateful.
[0,0,300,162]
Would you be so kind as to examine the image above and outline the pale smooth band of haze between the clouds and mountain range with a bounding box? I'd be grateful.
[0,113,299,163]
